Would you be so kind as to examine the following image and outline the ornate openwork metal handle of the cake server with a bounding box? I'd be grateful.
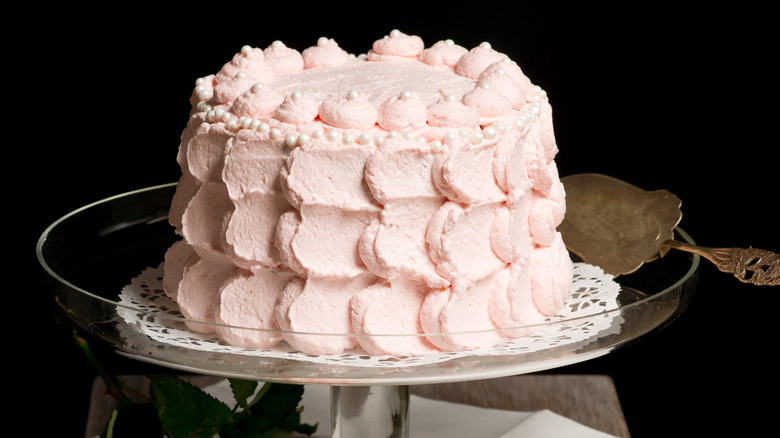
[661,240,780,286]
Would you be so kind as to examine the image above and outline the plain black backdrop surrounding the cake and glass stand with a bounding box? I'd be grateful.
[21,1,780,438]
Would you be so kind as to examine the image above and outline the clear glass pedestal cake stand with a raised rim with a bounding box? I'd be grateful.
[37,183,699,438]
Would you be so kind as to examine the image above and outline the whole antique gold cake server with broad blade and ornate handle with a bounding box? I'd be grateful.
[558,173,780,286]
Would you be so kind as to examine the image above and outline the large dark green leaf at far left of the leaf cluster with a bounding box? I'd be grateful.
[149,376,232,438]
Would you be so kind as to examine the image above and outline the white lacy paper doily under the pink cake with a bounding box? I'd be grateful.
[119,263,622,367]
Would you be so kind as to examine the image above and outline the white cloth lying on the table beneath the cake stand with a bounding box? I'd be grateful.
[204,380,615,438]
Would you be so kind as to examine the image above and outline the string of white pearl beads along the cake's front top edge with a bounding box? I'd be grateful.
[195,84,547,152]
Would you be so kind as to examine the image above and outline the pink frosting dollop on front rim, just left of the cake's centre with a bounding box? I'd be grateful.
[319,91,379,129]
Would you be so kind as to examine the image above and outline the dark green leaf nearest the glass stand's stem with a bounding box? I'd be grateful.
[220,383,303,438]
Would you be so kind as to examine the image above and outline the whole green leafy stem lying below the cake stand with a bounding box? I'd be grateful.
[76,337,317,438]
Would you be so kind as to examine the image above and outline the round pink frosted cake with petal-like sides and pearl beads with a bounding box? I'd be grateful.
[163,30,572,355]
